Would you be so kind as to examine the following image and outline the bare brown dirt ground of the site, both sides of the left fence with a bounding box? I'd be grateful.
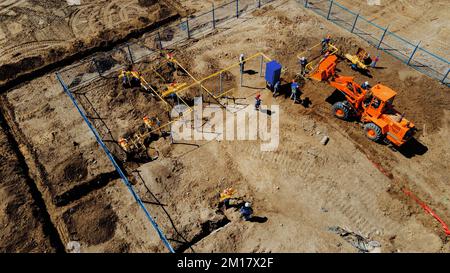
[0,0,450,252]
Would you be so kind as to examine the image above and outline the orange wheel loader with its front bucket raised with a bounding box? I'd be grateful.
[310,55,416,147]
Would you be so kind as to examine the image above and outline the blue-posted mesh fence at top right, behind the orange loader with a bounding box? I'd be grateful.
[302,0,450,86]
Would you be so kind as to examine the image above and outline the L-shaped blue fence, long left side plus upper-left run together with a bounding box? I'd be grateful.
[56,0,273,253]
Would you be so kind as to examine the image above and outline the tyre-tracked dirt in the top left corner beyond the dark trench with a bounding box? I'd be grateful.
[0,0,183,84]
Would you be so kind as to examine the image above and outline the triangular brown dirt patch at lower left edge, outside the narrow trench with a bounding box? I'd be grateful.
[0,116,56,253]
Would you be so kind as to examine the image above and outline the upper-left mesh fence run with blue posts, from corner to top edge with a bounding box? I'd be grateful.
[59,0,274,91]
